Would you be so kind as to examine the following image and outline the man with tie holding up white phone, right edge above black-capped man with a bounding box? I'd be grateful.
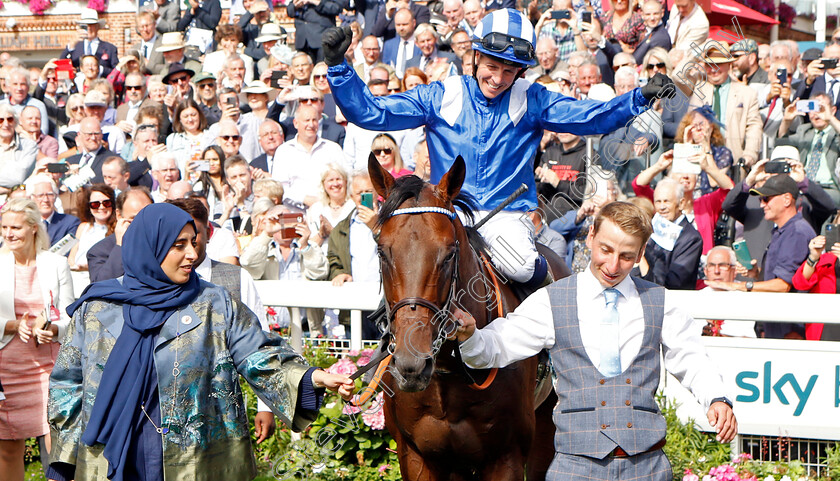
[777,93,840,206]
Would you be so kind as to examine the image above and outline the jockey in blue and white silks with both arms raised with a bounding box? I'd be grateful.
[322,9,674,288]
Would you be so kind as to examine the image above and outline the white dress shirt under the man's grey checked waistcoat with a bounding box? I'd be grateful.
[460,268,726,409]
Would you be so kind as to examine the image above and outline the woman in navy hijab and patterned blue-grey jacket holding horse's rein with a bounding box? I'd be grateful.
[47,204,353,481]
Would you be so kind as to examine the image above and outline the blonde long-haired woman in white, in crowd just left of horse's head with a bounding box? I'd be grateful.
[306,163,356,251]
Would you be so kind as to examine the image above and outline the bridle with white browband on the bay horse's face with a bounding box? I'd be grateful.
[380,207,461,356]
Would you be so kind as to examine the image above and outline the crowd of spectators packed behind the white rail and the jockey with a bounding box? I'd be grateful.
[0,0,840,348]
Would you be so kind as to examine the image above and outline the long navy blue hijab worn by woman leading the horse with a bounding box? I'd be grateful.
[67,204,200,481]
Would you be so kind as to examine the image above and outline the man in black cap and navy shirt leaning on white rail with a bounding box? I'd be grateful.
[707,174,817,339]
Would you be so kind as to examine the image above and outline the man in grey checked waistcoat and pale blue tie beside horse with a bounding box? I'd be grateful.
[453,202,738,481]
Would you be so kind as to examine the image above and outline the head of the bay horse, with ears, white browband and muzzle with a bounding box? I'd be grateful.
[368,156,469,392]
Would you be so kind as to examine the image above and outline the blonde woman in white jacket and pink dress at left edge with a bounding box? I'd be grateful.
[0,198,73,481]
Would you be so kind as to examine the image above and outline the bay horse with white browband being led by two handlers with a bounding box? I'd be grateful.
[368,156,557,481]
